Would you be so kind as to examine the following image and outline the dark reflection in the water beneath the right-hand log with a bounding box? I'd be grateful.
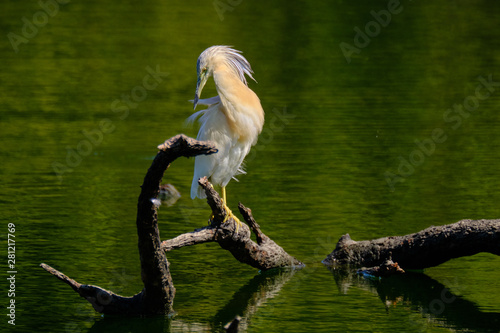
[330,269,500,332]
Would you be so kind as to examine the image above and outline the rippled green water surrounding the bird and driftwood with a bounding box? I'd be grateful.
[0,1,500,332]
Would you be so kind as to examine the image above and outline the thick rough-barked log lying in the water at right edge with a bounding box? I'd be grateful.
[323,220,500,269]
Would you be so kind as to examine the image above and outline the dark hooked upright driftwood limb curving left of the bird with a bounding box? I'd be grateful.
[40,134,217,315]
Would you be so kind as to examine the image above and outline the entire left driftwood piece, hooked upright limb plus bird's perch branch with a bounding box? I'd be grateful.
[40,134,303,315]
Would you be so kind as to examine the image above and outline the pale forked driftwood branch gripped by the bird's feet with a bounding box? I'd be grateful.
[162,177,304,271]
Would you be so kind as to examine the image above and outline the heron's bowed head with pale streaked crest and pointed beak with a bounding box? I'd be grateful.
[193,45,255,109]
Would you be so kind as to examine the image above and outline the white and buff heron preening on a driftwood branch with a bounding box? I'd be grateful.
[188,45,264,227]
